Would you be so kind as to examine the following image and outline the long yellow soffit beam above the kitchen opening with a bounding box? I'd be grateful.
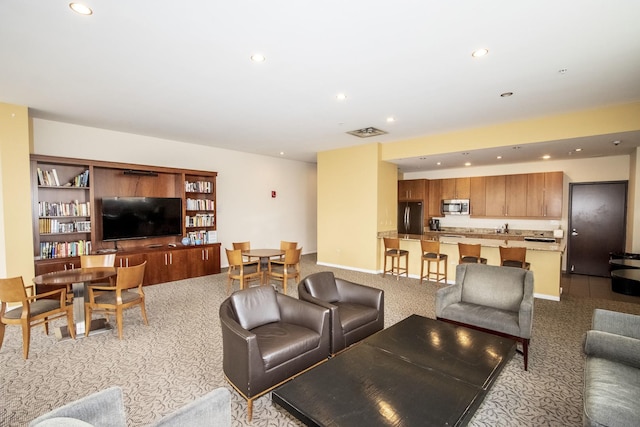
[382,103,640,160]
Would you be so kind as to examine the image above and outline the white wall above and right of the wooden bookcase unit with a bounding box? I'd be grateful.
[33,119,317,266]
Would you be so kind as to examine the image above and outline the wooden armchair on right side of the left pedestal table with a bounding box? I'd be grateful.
[84,261,149,339]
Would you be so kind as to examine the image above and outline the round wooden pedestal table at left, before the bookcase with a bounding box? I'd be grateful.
[33,267,118,340]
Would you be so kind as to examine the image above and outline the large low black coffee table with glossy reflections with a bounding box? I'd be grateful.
[272,315,516,427]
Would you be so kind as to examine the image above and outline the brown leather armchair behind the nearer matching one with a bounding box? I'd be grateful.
[298,271,384,354]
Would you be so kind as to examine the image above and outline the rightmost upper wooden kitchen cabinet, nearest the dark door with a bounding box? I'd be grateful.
[527,172,563,219]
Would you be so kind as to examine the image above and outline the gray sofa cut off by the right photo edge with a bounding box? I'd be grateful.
[583,309,640,427]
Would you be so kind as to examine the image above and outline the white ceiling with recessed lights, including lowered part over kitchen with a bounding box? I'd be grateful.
[0,0,640,171]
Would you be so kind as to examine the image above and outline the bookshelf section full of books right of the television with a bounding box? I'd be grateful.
[184,175,218,244]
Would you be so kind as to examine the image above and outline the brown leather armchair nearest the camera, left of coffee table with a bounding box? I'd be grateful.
[220,286,330,421]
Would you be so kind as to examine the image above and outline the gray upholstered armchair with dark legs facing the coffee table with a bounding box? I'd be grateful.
[436,264,533,371]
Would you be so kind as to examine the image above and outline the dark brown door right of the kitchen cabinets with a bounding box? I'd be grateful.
[567,181,627,276]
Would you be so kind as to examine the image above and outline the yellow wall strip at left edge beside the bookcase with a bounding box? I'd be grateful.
[0,103,34,285]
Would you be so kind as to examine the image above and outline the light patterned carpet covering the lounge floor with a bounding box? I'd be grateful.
[0,254,640,427]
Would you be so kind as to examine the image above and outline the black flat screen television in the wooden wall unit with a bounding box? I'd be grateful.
[102,197,182,240]
